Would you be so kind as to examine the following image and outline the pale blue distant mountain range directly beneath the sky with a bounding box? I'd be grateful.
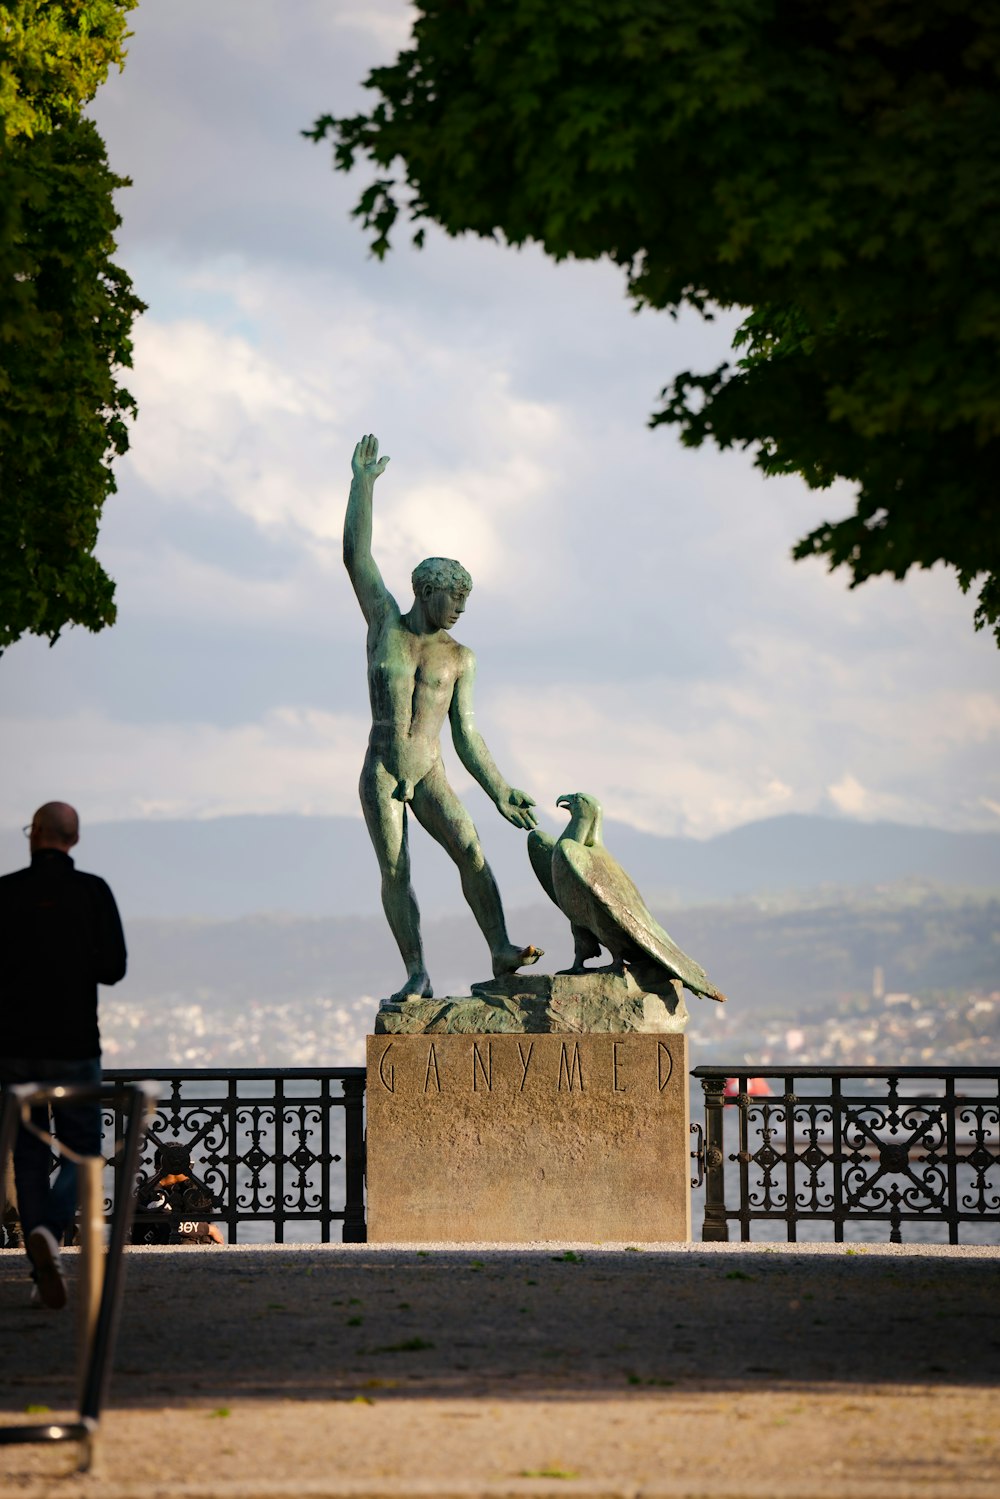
[0,808,1000,920]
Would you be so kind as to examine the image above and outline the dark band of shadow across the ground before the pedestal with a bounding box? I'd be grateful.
[0,1246,1000,1412]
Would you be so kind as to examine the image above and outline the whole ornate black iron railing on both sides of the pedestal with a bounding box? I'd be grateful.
[11,1066,1000,1244]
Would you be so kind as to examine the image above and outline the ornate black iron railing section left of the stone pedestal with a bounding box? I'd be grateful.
[105,1067,366,1244]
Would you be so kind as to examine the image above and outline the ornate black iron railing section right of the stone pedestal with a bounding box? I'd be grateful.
[691,1066,1000,1244]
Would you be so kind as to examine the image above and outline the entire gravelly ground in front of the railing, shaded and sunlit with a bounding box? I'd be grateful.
[0,1244,1000,1499]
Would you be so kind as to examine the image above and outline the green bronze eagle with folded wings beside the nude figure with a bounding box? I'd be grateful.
[528,791,726,1001]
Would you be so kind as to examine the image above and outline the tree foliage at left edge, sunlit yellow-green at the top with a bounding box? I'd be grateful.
[0,0,142,649]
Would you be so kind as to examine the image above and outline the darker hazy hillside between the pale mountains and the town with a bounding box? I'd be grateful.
[121,893,1000,1013]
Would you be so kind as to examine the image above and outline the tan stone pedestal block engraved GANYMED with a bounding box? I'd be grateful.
[367,1033,691,1244]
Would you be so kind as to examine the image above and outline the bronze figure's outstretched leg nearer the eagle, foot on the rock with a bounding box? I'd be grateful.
[411,761,543,977]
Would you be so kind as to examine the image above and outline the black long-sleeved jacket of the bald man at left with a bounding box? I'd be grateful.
[0,848,126,1058]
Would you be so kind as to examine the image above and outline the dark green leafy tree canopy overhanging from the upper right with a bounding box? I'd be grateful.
[304,0,1000,640]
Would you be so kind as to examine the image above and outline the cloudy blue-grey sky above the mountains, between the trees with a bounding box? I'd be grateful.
[0,0,1000,835]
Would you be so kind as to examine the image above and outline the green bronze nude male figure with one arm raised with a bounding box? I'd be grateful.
[343,436,541,1000]
